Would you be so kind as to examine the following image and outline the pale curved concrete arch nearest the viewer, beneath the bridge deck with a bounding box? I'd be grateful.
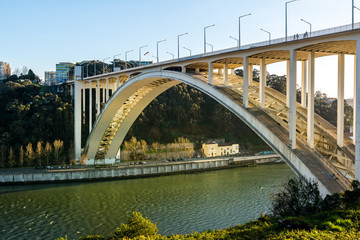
[84,71,344,195]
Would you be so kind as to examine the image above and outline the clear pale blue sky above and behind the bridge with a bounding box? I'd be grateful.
[0,0,360,98]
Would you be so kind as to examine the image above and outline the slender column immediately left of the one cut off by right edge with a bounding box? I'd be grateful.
[336,54,345,147]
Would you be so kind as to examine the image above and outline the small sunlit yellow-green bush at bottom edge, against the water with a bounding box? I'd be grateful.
[112,211,159,239]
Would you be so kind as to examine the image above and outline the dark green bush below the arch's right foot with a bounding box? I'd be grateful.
[271,178,322,217]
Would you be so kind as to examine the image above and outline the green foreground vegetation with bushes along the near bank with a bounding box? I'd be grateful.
[58,178,360,240]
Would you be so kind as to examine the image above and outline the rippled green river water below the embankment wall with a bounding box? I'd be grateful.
[0,164,294,239]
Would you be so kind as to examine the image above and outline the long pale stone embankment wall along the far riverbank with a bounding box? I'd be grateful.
[0,154,281,185]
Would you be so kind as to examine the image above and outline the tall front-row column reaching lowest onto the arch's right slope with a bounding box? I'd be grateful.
[289,49,297,149]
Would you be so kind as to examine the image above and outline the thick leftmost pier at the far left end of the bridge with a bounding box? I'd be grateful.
[74,66,84,161]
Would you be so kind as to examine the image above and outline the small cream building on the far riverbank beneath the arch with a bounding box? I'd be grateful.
[201,141,239,157]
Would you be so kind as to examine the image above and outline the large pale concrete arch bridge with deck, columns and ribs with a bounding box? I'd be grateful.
[71,24,360,195]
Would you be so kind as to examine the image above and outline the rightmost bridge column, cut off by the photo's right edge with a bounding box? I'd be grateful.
[354,39,360,180]
